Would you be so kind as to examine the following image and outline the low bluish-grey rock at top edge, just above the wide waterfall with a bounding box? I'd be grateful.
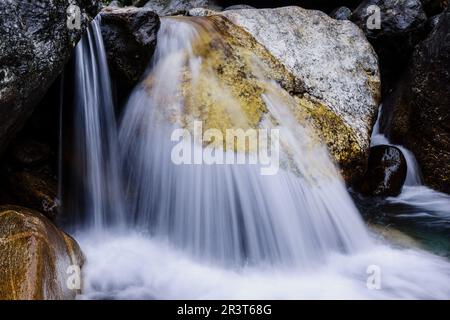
[144,0,222,16]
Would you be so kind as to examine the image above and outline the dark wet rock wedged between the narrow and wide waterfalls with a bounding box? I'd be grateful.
[101,7,160,98]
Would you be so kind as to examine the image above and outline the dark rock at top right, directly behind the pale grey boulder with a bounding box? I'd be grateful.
[351,0,427,87]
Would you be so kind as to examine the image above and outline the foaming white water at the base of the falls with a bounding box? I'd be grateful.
[78,233,450,300]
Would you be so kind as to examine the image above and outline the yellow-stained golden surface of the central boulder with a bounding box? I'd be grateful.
[146,14,378,182]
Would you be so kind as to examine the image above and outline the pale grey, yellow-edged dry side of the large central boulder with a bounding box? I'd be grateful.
[190,7,380,182]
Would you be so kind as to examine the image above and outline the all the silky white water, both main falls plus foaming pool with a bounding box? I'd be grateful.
[68,18,450,299]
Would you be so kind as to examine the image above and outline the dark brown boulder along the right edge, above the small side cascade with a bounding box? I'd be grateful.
[384,8,450,193]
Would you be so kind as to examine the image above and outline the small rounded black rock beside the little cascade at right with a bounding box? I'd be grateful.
[356,145,406,197]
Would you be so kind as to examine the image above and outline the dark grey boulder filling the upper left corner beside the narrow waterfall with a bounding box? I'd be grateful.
[0,0,97,152]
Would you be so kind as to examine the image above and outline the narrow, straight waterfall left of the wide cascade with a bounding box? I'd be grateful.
[65,17,125,228]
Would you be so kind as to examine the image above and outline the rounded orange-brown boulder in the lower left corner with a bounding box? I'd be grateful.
[0,206,84,300]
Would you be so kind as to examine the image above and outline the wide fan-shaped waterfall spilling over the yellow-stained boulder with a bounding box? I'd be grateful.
[120,18,370,266]
